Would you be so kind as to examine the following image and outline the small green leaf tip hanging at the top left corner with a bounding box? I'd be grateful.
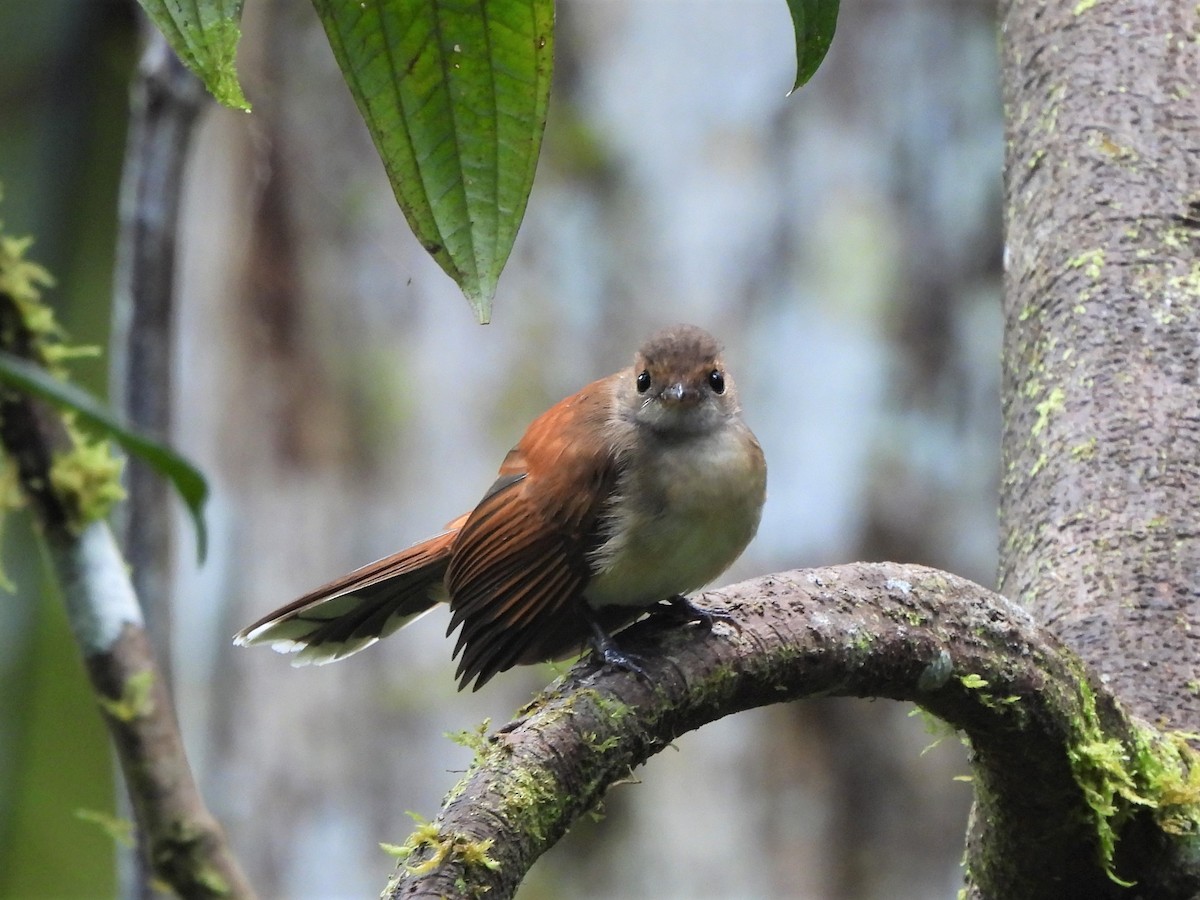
[138,0,250,112]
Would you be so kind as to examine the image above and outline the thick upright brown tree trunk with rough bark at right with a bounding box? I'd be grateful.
[1000,0,1200,732]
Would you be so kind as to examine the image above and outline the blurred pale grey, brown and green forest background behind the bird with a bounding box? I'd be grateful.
[0,0,1002,900]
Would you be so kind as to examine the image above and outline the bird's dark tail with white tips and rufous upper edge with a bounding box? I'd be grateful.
[234,521,462,666]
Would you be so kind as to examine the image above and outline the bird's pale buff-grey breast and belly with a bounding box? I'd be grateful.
[584,424,766,606]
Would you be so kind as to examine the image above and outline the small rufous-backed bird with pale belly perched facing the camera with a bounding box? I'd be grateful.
[234,325,767,690]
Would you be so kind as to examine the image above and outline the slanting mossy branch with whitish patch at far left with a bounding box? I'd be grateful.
[0,294,253,898]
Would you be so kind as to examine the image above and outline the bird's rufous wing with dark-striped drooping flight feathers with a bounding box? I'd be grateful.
[446,379,619,689]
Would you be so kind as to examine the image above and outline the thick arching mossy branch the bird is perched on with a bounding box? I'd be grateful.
[385,564,1200,899]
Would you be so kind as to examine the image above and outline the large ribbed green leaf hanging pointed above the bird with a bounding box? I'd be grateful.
[313,0,554,322]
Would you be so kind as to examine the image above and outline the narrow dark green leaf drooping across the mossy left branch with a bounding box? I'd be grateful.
[0,350,209,562]
